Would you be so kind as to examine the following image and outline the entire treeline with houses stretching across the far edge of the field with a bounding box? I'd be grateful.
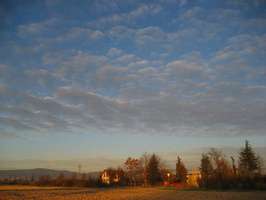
[0,141,266,190]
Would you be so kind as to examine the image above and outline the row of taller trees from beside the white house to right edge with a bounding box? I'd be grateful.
[105,141,266,189]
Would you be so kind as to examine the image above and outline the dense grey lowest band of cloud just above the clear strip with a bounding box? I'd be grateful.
[1,78,266,138]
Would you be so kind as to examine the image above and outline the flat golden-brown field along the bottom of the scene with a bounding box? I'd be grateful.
[0,186,266,200]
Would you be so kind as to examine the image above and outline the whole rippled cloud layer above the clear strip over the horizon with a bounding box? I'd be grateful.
[0,1,266,140]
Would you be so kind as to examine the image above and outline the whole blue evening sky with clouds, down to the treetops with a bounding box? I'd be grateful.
[0,0,266,171]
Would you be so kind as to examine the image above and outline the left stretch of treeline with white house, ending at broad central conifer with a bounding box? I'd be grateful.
[0,154,164,187]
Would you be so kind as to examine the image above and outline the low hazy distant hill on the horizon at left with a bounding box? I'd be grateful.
[0,168,99,180]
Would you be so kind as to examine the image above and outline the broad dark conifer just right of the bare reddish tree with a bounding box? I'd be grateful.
[147,154,162,185]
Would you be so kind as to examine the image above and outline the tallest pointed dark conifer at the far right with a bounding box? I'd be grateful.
[239,140,259,176]
